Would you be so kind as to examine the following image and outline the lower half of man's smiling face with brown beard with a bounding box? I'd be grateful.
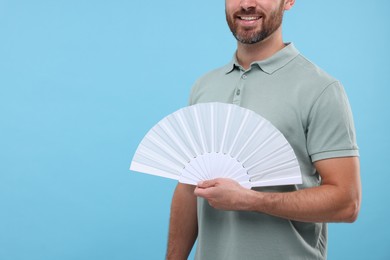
[225,0,284,44]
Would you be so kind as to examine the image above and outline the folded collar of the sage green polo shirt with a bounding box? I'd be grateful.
[224,43,299,74]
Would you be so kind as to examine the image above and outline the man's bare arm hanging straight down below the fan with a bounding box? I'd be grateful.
[167,183,198,260]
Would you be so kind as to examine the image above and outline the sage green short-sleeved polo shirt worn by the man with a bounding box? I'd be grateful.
[190,43,358,260]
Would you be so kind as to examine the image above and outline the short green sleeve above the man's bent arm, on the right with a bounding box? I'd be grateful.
[307,82,359,162]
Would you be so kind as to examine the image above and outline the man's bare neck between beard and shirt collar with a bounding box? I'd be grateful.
[236,28,285,69]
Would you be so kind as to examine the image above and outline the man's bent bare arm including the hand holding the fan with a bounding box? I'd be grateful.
[195,157,361,222]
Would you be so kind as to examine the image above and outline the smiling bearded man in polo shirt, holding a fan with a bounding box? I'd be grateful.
[167,0,361,260]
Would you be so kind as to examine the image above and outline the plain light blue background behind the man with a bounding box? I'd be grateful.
[0,0,390,260]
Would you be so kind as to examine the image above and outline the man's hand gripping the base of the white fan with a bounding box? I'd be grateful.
[194,178,250,210]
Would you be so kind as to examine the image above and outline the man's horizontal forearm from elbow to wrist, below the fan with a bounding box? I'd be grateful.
[247,185,359,222]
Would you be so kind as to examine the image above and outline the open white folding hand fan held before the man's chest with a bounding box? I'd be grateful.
[130,103,302,188]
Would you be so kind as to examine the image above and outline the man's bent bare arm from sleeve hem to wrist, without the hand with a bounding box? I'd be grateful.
[250,157,361,222]
